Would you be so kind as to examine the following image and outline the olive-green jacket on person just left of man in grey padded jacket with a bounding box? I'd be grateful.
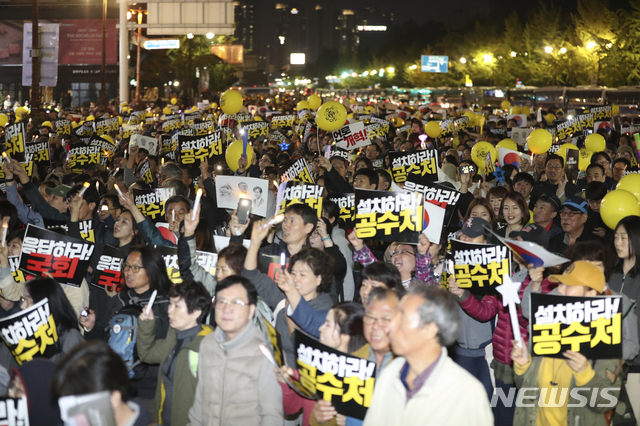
[138,320,213,426]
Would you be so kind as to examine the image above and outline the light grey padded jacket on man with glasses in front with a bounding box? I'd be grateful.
[189,322,284,426]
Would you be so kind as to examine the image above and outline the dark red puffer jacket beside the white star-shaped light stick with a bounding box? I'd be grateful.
[460,276,556,365]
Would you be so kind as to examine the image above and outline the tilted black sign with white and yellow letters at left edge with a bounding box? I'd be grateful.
[0,297,62,364]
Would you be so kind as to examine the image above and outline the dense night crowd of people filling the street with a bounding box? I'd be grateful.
[0,94,640,426]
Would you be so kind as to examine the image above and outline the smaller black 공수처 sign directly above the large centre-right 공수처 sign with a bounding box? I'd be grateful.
[389,149,438,183]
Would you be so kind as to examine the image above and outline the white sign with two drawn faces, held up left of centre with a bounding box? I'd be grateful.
[216,176,272,217]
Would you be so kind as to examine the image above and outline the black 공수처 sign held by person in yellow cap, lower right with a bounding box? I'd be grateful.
[529,293,622,360]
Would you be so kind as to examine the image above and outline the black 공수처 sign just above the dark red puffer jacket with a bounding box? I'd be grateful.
[451,240,511,295]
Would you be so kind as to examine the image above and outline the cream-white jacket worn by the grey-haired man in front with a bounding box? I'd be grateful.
[364,348,492,426]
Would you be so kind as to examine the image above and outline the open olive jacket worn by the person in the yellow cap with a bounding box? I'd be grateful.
[513,356,622,426]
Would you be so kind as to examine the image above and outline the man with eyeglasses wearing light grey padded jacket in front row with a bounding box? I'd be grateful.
[189,275,284,426]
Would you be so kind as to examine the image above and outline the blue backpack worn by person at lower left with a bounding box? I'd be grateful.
[108,305,148,379]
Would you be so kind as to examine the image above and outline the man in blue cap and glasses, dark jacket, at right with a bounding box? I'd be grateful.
[549,195,601,255]
